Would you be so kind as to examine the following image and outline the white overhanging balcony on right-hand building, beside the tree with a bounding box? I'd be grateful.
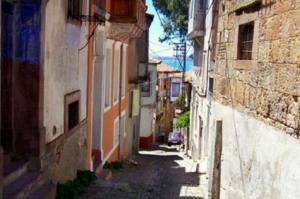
[187,0,205,39]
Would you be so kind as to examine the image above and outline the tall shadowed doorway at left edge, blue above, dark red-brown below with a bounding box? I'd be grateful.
[1,0,41,167]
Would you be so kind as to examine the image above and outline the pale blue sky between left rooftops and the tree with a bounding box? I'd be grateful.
[146,0,173,57]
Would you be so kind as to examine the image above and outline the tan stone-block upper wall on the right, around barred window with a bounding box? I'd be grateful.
[214,0,300,138]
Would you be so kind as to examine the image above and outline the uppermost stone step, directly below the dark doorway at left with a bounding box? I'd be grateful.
[3,160,28,186]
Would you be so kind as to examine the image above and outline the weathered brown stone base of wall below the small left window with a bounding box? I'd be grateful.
[41,121,86,183]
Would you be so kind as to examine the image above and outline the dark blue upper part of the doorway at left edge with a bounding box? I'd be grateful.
[2,0,41,64]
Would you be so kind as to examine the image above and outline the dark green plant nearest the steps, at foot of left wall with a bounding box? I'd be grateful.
[55,171,97,199]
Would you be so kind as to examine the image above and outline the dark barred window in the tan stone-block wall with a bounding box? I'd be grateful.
[238,22,254,60]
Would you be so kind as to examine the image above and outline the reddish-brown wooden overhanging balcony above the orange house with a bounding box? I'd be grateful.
[106,0,147,42]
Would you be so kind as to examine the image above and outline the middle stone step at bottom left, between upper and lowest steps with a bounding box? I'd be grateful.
[3,172,44,199]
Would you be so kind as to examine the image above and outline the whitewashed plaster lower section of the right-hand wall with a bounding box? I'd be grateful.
[206,101,300,199]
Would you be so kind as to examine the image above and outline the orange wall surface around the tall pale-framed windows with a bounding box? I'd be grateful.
[102,43,128,162]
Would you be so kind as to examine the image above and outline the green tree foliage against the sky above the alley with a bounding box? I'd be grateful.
[153,0,189,42]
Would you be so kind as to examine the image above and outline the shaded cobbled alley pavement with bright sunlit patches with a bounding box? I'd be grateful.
[81,145,203,199]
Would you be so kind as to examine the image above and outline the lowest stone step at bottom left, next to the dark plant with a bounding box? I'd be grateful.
[26,183,56,199]
